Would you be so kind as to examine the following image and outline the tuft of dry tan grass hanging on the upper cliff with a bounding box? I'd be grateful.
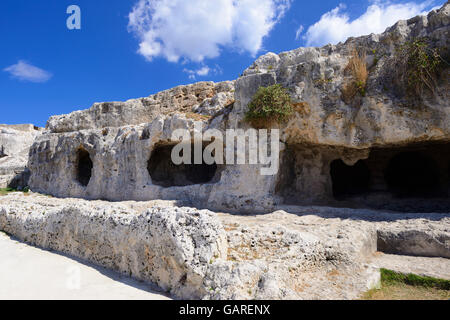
[342,49,369,104]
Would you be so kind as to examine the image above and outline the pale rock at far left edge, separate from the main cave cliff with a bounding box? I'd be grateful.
[0,125,42,188]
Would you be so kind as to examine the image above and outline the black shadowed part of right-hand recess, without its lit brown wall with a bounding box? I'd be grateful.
[330,143,450,212]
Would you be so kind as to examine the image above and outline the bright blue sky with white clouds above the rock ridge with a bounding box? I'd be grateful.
[0,0,445,126]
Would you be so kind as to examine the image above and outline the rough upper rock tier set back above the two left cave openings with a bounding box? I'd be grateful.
[47,81,234,133]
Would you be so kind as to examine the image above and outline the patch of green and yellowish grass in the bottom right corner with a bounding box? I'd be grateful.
[363,269,450,300]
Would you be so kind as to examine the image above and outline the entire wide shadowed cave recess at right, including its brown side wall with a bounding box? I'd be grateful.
[275,142,450,212]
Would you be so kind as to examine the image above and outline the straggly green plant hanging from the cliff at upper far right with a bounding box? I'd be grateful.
[395,38,446,97]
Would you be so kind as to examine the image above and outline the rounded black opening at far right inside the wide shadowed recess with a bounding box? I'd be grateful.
[385,151,442,198]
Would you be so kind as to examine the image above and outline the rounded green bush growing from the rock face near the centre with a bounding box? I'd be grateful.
[245,84,294,127]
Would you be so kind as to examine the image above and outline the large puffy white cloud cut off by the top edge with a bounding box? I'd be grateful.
[128,0,291,62]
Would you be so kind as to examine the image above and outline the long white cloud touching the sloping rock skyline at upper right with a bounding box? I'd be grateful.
[303,0,434,46]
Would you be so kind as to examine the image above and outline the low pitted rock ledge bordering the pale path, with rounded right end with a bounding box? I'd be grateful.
[0,192,227,299]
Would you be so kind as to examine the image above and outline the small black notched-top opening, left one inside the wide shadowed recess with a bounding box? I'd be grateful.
[330,160,370,200]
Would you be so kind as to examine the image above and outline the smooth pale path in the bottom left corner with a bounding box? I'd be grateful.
[0,232,169,300]
